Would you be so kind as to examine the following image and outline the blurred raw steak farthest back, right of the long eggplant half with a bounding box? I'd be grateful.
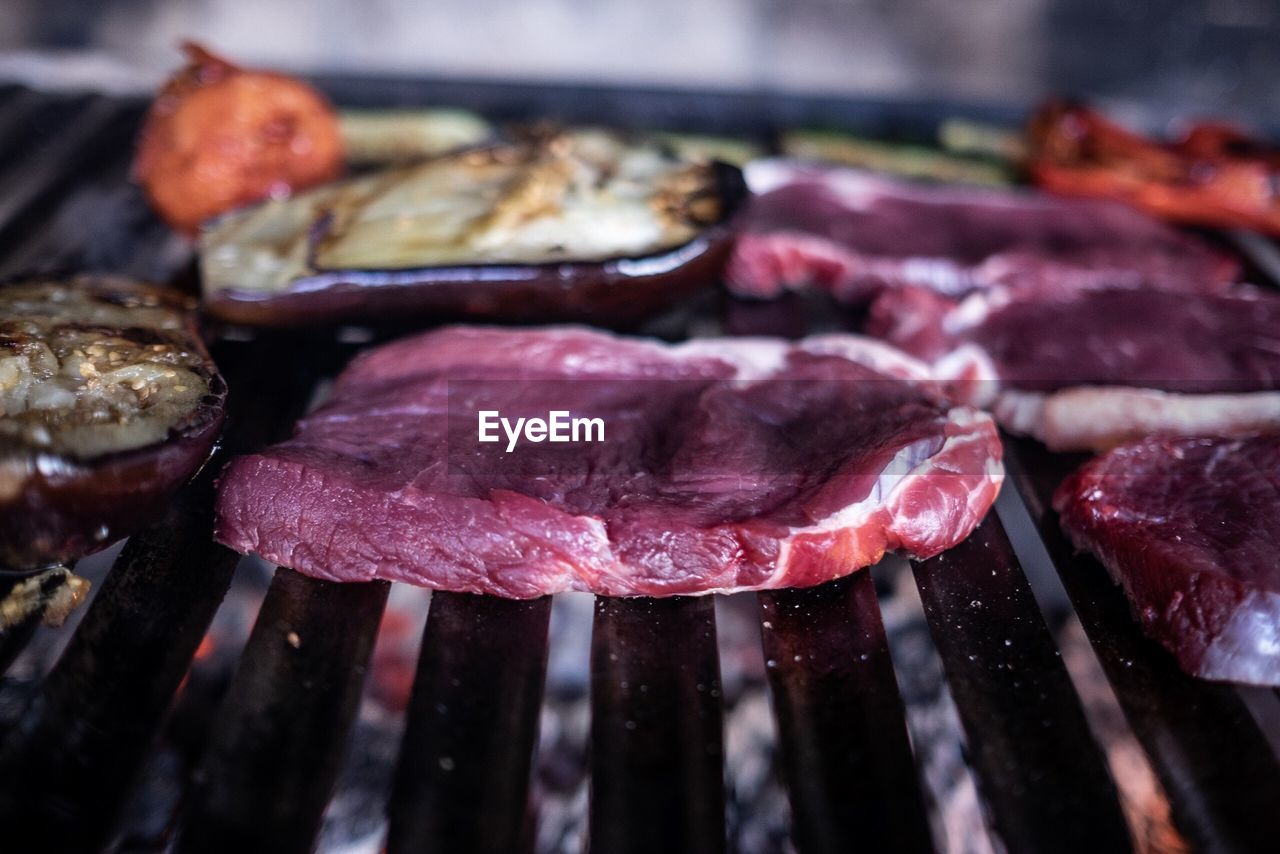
[726,160,1239,302]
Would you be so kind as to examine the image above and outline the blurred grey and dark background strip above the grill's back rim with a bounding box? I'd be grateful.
[0,0,1280,128]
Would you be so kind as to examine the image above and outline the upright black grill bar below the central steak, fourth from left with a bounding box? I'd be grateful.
[590,597,726,854]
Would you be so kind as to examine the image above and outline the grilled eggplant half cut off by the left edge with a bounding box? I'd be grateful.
[0,277,227,570]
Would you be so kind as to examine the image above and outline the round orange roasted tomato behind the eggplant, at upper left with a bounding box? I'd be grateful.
[133,42,343,234]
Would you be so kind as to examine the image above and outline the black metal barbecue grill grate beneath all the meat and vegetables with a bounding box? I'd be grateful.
[0,78,1280,854]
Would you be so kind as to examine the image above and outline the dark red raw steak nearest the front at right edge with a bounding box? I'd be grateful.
[1053,437,1280,685]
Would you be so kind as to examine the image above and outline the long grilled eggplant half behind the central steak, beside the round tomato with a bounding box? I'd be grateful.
[201,131,746,325]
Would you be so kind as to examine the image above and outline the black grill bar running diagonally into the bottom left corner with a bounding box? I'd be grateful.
[0,460,238,850]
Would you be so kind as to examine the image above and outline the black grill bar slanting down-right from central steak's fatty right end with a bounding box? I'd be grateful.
[913,513,1132,853]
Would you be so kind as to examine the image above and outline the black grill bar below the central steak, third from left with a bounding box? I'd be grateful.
[387,593,552,854]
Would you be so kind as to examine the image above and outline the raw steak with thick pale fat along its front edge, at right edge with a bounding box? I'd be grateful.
[870,287,1280,451]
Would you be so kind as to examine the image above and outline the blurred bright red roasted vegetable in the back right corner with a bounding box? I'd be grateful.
[1028,101,1280,234]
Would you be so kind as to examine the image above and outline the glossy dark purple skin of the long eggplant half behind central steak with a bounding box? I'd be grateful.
[204,147,749,328]
